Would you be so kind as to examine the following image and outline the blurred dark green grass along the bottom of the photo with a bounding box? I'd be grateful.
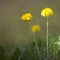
[0,34,60,60]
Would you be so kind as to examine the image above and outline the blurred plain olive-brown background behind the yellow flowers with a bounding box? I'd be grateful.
[0,0,60,47]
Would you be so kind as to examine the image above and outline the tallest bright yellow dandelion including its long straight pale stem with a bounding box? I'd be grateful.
[41,8,54,58]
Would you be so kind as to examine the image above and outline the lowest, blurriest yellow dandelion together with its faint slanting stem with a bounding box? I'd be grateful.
[32,25,41,59]
